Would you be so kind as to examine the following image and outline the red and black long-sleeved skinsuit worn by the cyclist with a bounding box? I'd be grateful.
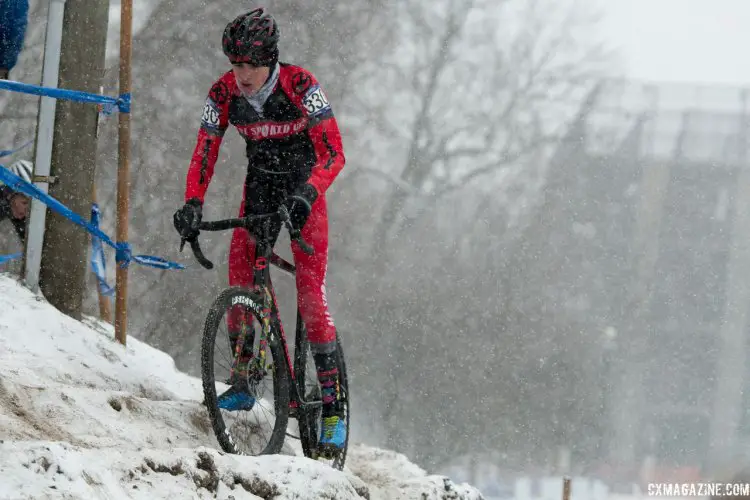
[185,63,345,353]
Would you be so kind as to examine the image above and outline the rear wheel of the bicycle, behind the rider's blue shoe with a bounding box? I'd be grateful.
[294,330,351,470]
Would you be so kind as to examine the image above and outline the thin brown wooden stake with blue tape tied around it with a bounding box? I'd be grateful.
[115,0,133,345]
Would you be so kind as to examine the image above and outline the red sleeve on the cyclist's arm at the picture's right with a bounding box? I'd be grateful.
[282,66,346,194]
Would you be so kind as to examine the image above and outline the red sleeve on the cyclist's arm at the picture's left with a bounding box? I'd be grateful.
[185,75,229,203]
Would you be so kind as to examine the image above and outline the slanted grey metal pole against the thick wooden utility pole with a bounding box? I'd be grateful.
[25,0,65,292]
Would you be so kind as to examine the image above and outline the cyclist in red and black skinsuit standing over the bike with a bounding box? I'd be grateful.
[174,8,347,454]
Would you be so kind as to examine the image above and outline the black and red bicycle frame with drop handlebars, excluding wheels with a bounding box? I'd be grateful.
[190,214,323,416]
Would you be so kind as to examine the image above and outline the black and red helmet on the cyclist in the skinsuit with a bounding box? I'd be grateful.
[226,7,279,66]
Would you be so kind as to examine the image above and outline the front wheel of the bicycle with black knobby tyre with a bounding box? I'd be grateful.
[201,287,290,455]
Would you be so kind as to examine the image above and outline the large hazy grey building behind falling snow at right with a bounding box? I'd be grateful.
[520,82,750,480]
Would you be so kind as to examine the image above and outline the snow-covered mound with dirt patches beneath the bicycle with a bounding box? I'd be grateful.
[0,275,481,500]
